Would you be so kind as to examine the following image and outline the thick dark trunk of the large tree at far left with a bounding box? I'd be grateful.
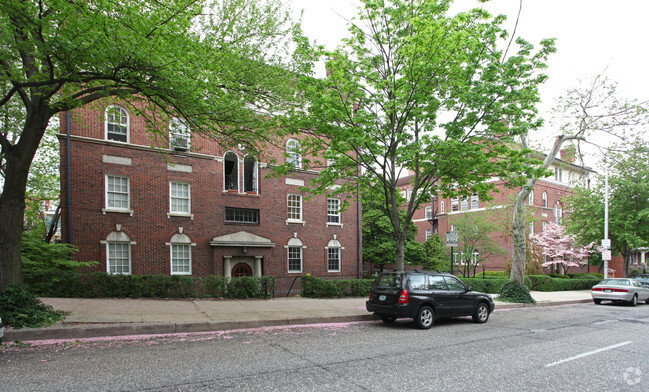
[0,108,49,291]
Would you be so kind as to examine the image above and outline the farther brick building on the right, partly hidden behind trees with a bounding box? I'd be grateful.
[399,151,593,272]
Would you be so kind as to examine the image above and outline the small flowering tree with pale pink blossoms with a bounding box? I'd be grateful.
[530,222,595,275]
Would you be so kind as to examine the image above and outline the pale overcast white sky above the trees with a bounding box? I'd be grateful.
[291,0,649,165]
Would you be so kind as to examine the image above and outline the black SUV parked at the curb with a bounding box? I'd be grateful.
[365,270,495,329]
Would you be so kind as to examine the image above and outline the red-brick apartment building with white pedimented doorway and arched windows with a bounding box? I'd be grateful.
[59,102,359,292]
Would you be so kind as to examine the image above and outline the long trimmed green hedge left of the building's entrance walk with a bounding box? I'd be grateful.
[24,271,275,298]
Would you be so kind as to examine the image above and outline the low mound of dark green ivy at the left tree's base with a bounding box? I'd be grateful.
[0,286,65,328]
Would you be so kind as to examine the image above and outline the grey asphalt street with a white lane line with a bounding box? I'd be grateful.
[0,303,649,391]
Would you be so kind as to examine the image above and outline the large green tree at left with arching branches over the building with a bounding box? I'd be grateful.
[0,0,308,289]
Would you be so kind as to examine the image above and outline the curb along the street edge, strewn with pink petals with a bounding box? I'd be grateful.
[4,299,592,342]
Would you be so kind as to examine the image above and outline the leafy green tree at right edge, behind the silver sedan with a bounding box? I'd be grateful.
[566,141,649,276]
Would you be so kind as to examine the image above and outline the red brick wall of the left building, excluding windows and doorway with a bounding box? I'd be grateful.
[60,105,358,290]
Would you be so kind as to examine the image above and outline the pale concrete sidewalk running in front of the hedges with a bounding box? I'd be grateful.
[5,290,592,342]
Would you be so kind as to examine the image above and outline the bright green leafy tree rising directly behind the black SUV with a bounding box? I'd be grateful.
[288,0,554,269]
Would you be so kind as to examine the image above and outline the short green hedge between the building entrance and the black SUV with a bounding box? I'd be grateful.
[300,275,374,298]
